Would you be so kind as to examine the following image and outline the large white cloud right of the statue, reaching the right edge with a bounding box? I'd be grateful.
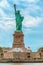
[23,16,43,27]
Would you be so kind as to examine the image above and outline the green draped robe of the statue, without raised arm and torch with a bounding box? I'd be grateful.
[15,12,24,31]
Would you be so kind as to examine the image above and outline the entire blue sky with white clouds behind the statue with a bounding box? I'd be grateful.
[0,0,43,51]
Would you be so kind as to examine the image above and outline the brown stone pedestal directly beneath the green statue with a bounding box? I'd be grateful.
[13,32,24,48]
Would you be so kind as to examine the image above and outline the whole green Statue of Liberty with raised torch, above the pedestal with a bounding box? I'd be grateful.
[14,4,24,32]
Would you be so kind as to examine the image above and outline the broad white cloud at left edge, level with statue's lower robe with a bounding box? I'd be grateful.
[0,20,15,30]
